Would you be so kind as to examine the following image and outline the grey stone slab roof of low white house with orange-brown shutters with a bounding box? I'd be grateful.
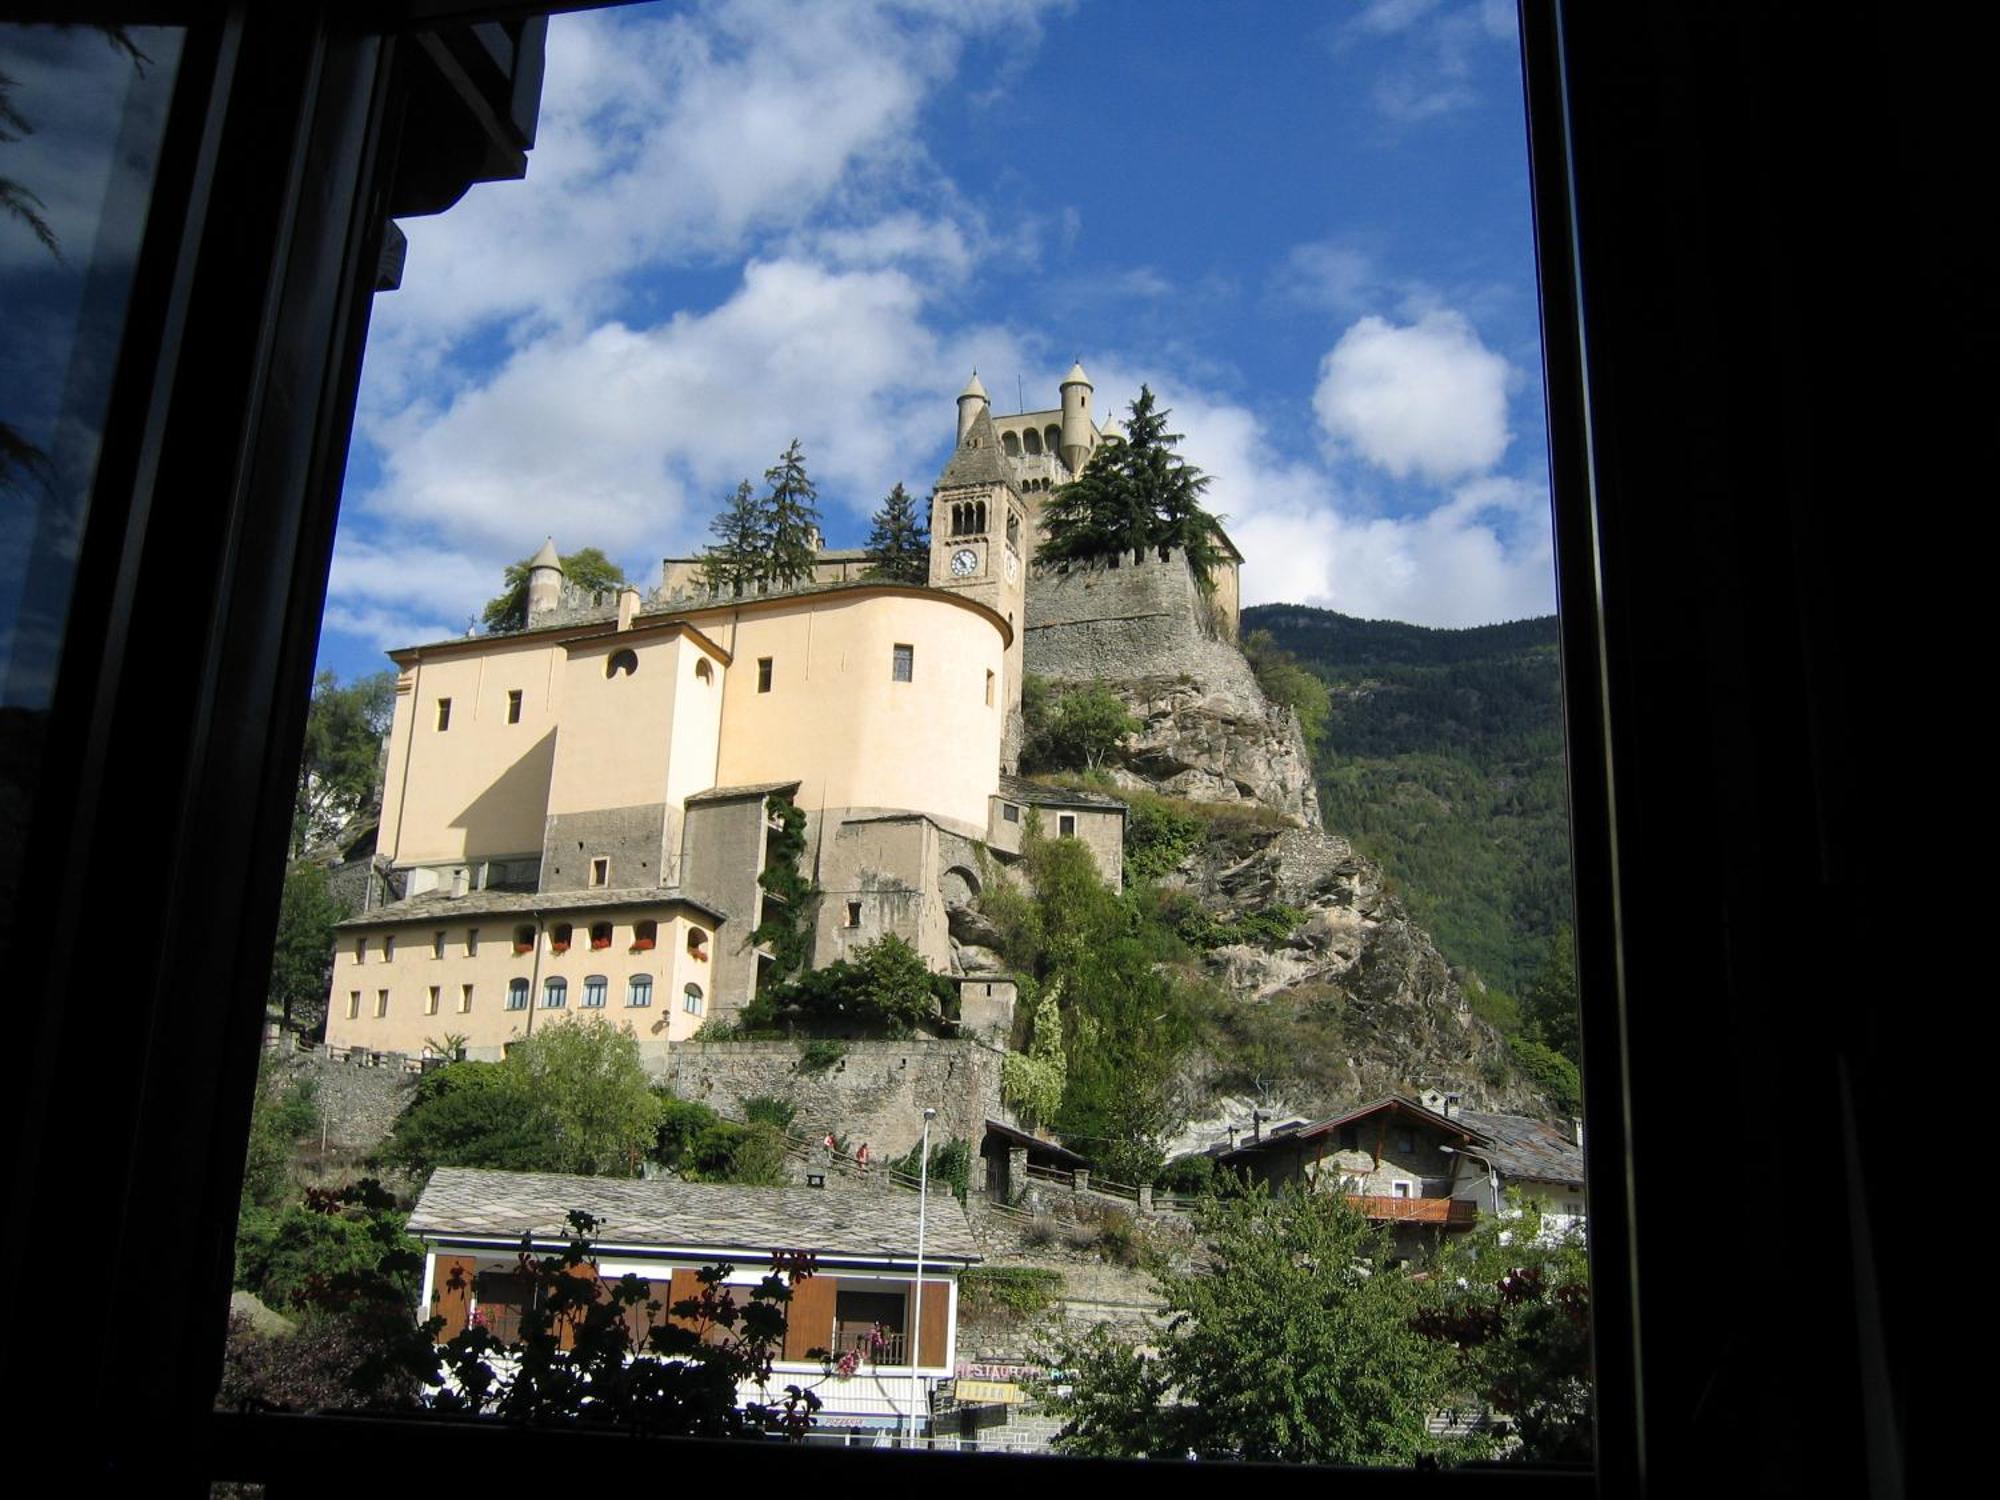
[410,1166,980,1262]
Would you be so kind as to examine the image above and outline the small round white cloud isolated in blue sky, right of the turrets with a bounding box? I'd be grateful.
[1312,308,1514,480]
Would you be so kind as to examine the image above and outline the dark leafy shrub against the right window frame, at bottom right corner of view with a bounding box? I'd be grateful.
[1416,1192,1592,1462]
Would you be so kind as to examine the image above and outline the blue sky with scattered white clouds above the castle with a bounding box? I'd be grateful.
[320,0,1554,676]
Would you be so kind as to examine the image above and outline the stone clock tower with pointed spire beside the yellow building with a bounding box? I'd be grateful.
[930,400,1034,740]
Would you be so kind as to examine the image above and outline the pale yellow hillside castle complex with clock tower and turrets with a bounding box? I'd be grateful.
[326,364,1240,1068]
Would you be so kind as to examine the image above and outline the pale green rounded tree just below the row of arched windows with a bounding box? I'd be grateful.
[504,1016,660,1176]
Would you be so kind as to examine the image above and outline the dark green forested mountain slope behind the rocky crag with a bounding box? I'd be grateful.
[1242,604,1570,996]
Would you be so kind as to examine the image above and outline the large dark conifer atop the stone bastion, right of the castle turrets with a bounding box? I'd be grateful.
[1040,386,1222,590]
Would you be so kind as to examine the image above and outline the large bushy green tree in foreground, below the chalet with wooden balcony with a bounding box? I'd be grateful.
[1046,1186,1452,1466]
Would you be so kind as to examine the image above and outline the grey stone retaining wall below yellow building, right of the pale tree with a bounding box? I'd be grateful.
[666,1040,1012,1160]
